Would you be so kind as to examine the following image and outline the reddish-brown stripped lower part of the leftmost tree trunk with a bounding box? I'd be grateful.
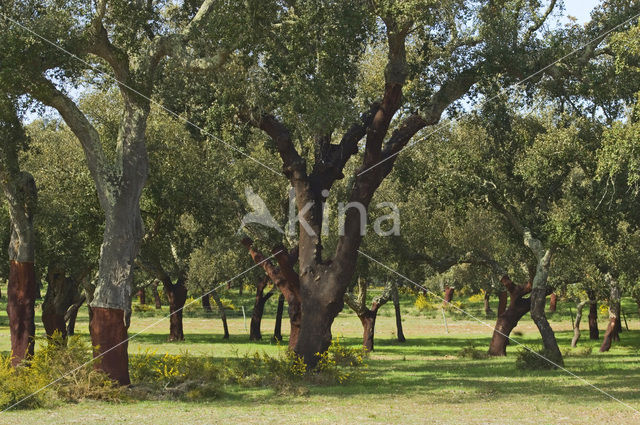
[7,261,37,366]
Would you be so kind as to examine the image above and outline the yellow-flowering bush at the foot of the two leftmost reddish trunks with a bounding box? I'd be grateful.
[0,333,124,408]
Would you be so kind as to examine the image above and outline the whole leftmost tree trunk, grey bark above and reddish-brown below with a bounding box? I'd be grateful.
[0,102,38,366]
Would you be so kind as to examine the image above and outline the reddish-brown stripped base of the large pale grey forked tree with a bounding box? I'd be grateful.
[89,307,131,385]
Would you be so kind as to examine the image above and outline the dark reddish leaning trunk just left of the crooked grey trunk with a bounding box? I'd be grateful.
[489,275,531,356]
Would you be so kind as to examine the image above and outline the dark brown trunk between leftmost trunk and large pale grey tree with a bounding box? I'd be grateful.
[42,266,77,338]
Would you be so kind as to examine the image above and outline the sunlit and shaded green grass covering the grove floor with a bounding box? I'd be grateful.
[0,286,640,425]
